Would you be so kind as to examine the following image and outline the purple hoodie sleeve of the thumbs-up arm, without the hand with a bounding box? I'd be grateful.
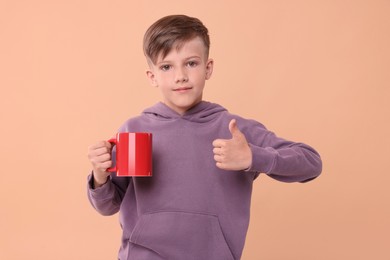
[244,120,322,182]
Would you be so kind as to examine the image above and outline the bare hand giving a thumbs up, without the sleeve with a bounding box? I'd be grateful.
[213,119,252,171]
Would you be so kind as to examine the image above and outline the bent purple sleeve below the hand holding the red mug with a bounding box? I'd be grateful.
[87,173,129,216]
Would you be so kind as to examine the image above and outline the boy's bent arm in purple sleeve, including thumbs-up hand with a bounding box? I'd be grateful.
[213,120,322,182]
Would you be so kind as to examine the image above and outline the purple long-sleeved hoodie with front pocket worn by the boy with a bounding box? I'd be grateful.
[88,101,322,260]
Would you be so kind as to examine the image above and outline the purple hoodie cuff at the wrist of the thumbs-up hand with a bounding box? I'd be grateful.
[245,144,277,173]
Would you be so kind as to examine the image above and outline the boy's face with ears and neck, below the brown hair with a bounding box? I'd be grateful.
[146,37,213,115]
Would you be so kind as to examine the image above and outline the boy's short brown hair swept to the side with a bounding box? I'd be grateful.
[143,15,210,64]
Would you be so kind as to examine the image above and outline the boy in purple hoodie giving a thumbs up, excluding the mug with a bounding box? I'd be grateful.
[88,15,322,260]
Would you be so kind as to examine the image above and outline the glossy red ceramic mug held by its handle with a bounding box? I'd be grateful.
[107,133,152,177]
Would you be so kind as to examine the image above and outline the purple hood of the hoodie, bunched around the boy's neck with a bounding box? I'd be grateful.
[142,101,227,123]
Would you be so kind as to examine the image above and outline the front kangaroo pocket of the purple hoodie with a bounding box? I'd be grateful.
[130,211,234,260]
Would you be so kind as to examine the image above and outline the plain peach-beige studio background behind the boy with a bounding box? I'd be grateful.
[0,0,390,260]
